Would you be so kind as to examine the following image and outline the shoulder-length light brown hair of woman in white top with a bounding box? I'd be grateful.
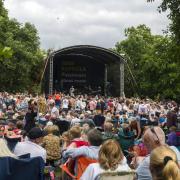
[99,140,124,170]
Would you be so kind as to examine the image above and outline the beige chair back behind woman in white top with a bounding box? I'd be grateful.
[95,171,135,180]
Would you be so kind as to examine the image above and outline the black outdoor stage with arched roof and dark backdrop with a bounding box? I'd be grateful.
[43,45,124,96]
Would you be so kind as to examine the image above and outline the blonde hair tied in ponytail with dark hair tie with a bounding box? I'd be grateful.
[150,145,180,180]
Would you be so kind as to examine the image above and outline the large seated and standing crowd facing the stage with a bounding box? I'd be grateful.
[0,92,180,180]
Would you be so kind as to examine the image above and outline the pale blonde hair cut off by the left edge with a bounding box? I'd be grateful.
[0,138,16,158]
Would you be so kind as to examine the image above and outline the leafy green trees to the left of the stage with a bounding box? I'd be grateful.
[0,0,44,92]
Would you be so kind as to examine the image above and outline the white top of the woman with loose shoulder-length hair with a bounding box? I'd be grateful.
[80,157,131,180]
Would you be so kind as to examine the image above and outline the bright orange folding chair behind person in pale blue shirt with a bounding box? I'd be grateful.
[60,156,97,180]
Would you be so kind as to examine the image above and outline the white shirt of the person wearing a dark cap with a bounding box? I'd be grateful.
[14,141,46,162]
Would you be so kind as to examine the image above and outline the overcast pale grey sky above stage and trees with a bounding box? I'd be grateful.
[5,0,168,49]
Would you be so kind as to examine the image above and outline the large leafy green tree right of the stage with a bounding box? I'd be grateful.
[115,25,180,99]
